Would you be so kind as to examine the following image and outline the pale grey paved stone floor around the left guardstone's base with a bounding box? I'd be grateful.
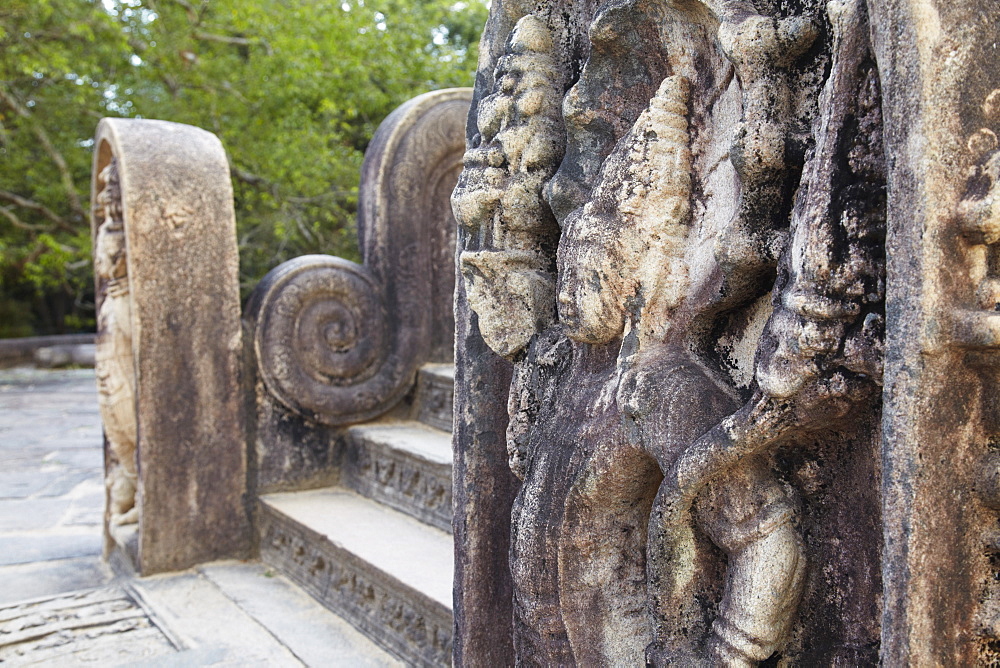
[0,369,401,668]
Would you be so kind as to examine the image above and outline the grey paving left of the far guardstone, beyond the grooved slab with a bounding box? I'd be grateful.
[0,369,111,605]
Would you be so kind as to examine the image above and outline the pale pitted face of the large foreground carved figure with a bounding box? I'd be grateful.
[557,207,627,344]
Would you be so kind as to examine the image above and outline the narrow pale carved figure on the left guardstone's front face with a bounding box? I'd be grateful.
[94,159,138,524]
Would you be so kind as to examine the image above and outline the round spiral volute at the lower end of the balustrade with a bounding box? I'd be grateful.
[253,255,398,424]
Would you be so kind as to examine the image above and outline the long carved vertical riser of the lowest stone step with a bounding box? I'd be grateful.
[260,504,452,666]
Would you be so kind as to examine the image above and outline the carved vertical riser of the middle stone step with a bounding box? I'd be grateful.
[341,431,452,533]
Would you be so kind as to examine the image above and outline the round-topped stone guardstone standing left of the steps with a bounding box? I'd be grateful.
[92,119,251,575]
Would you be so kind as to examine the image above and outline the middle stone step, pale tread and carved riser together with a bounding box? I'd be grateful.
[341,420,452,533]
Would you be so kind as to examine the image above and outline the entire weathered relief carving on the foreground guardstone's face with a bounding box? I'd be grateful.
[453,0,885,666]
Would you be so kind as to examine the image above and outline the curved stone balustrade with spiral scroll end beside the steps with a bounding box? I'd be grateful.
[246,89,471,425]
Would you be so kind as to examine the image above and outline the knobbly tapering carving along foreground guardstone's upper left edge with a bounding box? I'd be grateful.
[454,15,563,356]
